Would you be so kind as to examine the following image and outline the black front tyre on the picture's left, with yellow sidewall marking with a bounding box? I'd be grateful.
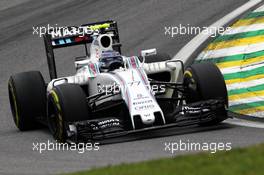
[48,84,89,142]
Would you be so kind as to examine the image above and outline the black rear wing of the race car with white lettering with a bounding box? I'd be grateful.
[43,20,121,80]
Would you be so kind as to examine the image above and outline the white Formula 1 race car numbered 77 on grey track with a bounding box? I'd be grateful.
[8,21,228,142]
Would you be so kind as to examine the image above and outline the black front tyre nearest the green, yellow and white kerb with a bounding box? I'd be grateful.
[183,63,228,125]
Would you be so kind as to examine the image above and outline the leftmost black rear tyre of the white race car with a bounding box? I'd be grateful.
[8,71,46,131]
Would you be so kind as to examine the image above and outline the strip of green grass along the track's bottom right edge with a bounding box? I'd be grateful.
[64,144,264,175]
